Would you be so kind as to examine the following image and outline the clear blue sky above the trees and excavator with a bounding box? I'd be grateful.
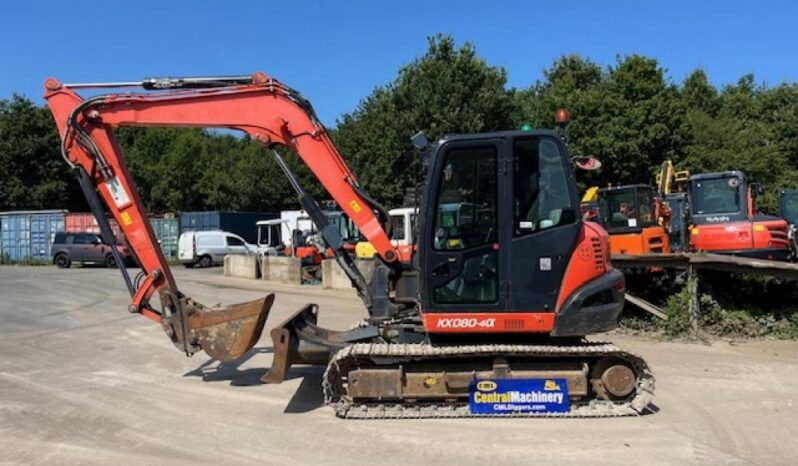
[0,0,798,126]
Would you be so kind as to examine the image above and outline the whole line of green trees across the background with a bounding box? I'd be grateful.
[0,36,798,212]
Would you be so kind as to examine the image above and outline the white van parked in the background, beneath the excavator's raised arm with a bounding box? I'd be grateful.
[177,230,258,268]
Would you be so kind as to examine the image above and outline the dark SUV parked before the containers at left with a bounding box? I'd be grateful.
[51,231,133,269]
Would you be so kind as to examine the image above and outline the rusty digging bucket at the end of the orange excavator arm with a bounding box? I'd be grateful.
[188,293,274,362]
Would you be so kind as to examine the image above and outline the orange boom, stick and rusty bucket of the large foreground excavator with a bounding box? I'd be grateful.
[45,72,398,361]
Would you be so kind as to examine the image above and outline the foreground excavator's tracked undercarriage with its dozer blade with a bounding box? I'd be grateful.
[261,304,654,419]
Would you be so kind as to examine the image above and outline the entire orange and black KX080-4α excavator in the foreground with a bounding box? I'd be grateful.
[45,73,654,418]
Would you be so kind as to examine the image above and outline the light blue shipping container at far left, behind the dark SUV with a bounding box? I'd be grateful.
[0,210,66,262]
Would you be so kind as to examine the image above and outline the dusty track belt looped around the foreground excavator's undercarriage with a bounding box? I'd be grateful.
[322,342,654,419]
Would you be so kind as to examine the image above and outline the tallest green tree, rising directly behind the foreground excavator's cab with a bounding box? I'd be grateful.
[334,36,514,205]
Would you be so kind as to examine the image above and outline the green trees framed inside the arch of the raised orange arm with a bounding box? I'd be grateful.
[118,128,304,212]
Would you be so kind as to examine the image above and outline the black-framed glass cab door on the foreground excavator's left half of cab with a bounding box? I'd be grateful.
[419,138,510,313]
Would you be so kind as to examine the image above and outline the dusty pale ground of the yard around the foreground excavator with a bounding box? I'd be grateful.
[0,266,798,465]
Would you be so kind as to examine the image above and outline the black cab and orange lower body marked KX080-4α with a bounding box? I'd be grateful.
[419,130,623,334]
